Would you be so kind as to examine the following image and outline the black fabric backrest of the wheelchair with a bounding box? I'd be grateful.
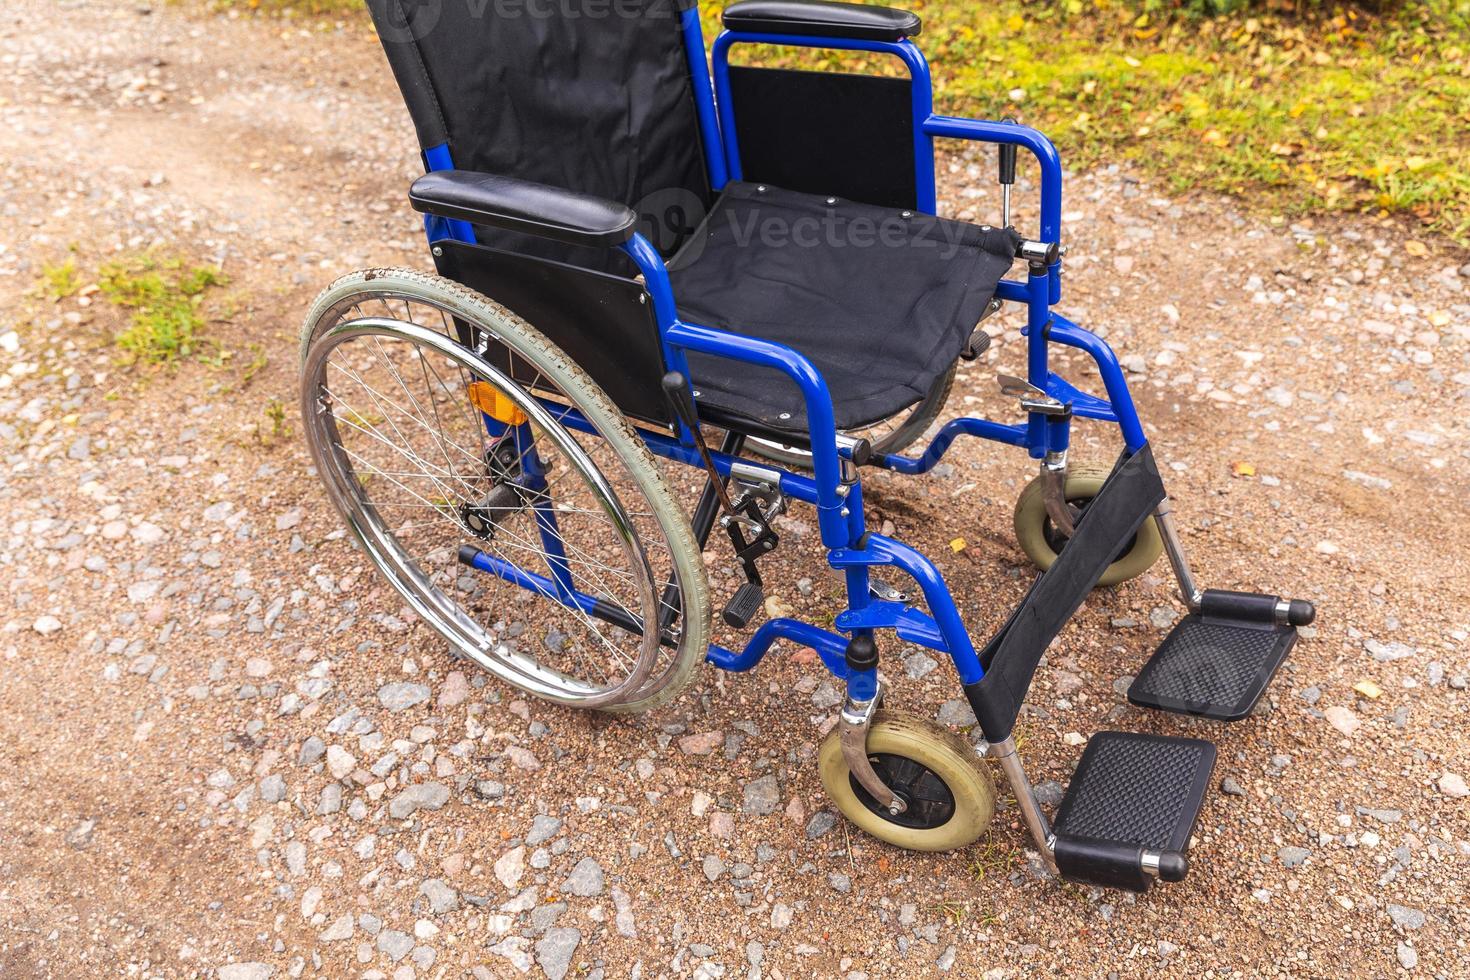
[368,0,710,272]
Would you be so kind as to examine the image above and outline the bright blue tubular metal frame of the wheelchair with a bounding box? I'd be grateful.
[425,9,1145,698]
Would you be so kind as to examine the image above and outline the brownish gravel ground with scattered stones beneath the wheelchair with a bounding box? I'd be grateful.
[0,0,1470,980]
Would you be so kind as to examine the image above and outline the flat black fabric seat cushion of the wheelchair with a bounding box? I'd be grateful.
[669,182,1017,432]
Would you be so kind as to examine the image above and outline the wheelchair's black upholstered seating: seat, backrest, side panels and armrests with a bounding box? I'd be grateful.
[368,0,1016,436]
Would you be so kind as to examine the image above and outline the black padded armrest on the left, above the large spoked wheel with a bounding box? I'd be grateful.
[409,170,638,247]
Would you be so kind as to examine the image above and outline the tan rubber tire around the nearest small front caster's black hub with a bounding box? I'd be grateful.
[817,708,995,851]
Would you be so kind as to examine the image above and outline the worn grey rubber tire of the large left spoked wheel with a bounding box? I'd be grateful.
[300,269,711,714]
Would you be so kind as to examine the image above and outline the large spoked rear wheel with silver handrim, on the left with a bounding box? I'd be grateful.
[301,270,710,711]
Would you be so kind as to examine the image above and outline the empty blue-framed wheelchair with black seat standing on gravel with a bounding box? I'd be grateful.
[301,0,1314,890]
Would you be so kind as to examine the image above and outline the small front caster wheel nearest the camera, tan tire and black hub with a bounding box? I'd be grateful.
[817,710,995,851]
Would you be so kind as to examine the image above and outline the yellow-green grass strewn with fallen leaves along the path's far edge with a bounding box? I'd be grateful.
[213,0,1470,244]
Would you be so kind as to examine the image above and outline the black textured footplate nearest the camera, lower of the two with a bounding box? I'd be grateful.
[1053,732,1214,892]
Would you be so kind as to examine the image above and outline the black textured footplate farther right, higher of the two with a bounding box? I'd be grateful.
[1127,591,1313,721]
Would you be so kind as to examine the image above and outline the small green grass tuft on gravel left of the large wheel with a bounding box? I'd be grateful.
[97,256,225,364]
